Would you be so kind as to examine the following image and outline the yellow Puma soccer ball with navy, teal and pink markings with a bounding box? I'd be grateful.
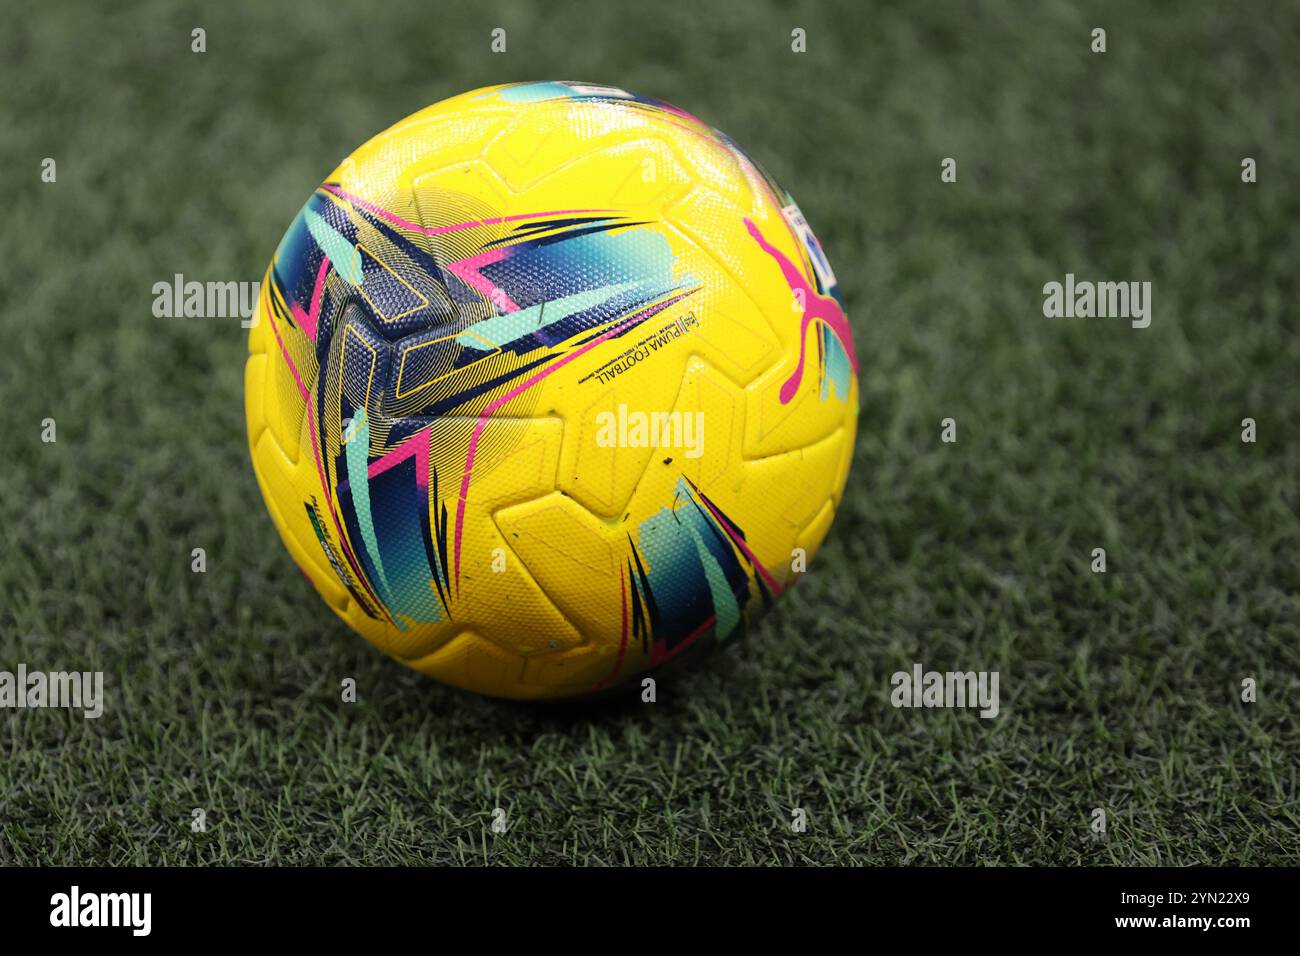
[246,82,858,698]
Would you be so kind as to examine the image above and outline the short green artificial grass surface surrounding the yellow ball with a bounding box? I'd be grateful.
[0,0,1300,865]
